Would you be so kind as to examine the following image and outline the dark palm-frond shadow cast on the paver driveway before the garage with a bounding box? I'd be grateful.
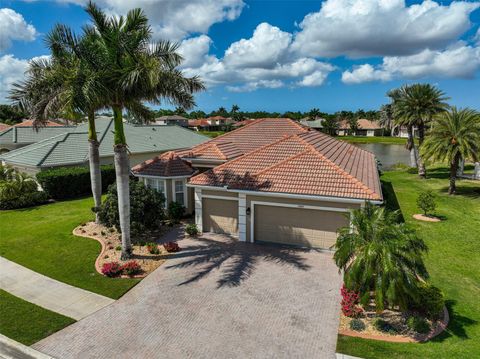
[167,236,310,288]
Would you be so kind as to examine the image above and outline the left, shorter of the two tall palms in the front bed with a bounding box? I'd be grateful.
[10,25,106,223]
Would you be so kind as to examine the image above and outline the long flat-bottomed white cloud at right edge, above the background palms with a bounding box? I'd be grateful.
[342,41,480,84]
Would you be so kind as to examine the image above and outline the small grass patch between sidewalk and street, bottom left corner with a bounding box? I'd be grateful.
[0,289,75,345]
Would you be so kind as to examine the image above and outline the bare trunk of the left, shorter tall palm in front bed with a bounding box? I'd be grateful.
[88,112,102,223]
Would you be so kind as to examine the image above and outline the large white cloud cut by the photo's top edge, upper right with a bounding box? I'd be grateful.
[293,0,480,57]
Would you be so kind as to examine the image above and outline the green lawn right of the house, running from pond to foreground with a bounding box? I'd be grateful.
[337,168,480,359]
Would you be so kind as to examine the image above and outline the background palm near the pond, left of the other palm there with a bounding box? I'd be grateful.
[394,84,448,178]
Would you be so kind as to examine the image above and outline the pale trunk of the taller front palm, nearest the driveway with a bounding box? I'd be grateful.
[112,106,132,260]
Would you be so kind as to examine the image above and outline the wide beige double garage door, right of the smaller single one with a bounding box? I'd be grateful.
[254,205,349,249]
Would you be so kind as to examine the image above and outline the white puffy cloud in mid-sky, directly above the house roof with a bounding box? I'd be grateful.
[180,23,335,92]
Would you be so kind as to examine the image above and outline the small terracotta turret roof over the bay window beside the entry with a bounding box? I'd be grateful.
[132,151,196,177]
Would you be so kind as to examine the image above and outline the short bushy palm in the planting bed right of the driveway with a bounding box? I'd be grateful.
[334,203,428,311]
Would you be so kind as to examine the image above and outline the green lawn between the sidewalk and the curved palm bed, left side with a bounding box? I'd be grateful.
[0,198,139,299]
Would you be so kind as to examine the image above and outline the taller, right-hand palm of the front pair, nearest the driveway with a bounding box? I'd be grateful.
[76,2,204,259]
